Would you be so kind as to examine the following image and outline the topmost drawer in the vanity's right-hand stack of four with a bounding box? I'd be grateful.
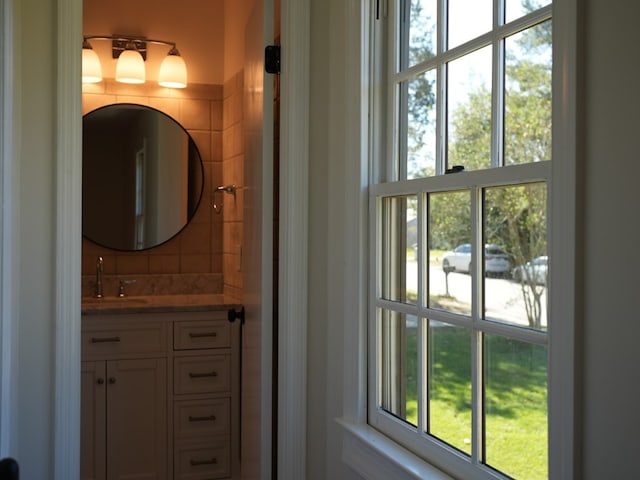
[173,320,231,350]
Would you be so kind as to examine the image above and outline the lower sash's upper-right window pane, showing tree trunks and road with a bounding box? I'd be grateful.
[484,183,547,330]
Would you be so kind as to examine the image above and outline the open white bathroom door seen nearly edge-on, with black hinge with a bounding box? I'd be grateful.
[241,0,274,479]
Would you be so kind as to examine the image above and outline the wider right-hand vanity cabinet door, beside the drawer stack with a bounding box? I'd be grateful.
[106,359,168,480]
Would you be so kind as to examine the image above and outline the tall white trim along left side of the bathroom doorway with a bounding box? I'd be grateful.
[53,0,82,480]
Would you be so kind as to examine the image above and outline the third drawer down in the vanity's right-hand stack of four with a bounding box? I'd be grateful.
[173,398,231,439]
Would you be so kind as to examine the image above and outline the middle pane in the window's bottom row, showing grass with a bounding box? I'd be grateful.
[428,321,471,455]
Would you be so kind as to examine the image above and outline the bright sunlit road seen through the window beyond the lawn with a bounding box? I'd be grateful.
[407,262,547,327]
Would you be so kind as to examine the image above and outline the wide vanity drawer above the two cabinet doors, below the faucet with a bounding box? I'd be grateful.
[82,321,167,357]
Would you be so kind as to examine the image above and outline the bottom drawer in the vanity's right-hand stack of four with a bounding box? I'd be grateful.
[174,439,231,480]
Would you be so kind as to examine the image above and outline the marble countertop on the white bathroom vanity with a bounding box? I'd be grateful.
[82,294,241,315]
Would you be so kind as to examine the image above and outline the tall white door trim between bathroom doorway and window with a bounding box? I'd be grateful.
[277,0,311,479]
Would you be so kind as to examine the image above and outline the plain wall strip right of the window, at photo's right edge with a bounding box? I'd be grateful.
[579,0,640,480]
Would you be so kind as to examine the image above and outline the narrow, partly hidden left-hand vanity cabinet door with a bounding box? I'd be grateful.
[80,362,107,480]
